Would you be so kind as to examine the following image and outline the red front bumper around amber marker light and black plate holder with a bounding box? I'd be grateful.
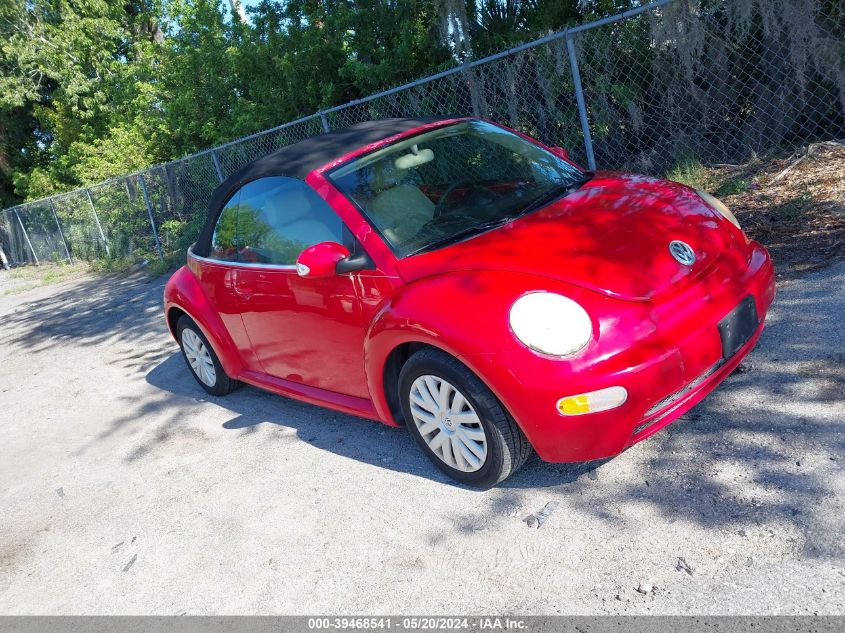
[463,243,775,462]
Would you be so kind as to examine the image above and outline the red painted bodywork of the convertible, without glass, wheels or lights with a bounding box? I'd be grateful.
[165,121,775,462]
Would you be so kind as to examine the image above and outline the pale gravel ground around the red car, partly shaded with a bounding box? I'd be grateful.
[0,264,845,614]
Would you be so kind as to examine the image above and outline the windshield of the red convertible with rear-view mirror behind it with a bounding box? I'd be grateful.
[329,121,585,257]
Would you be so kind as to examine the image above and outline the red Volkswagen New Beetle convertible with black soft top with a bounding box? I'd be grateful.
[165,119,775,487]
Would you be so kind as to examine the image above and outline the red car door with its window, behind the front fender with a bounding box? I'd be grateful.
[226,177,369,398]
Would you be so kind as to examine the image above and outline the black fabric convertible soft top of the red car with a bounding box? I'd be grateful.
[193,117,450,257]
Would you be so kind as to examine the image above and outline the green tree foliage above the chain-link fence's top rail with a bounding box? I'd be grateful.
[0,0,620,206]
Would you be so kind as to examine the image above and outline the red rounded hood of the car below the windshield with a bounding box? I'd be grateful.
[397,172,738,301]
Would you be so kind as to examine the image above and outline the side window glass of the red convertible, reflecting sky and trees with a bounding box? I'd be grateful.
[211,176,343,266]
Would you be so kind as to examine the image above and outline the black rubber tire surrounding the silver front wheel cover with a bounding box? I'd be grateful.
[399,350,507,488]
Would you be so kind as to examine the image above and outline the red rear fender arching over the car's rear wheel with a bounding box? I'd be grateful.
[164,266,244,378]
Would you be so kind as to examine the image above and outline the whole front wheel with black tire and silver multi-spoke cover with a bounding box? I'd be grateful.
[399,348,532,488]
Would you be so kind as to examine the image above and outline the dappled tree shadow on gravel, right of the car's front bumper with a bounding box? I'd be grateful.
[505,267,845,559]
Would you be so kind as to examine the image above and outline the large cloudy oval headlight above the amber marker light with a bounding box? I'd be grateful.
[509,292,593,356]
